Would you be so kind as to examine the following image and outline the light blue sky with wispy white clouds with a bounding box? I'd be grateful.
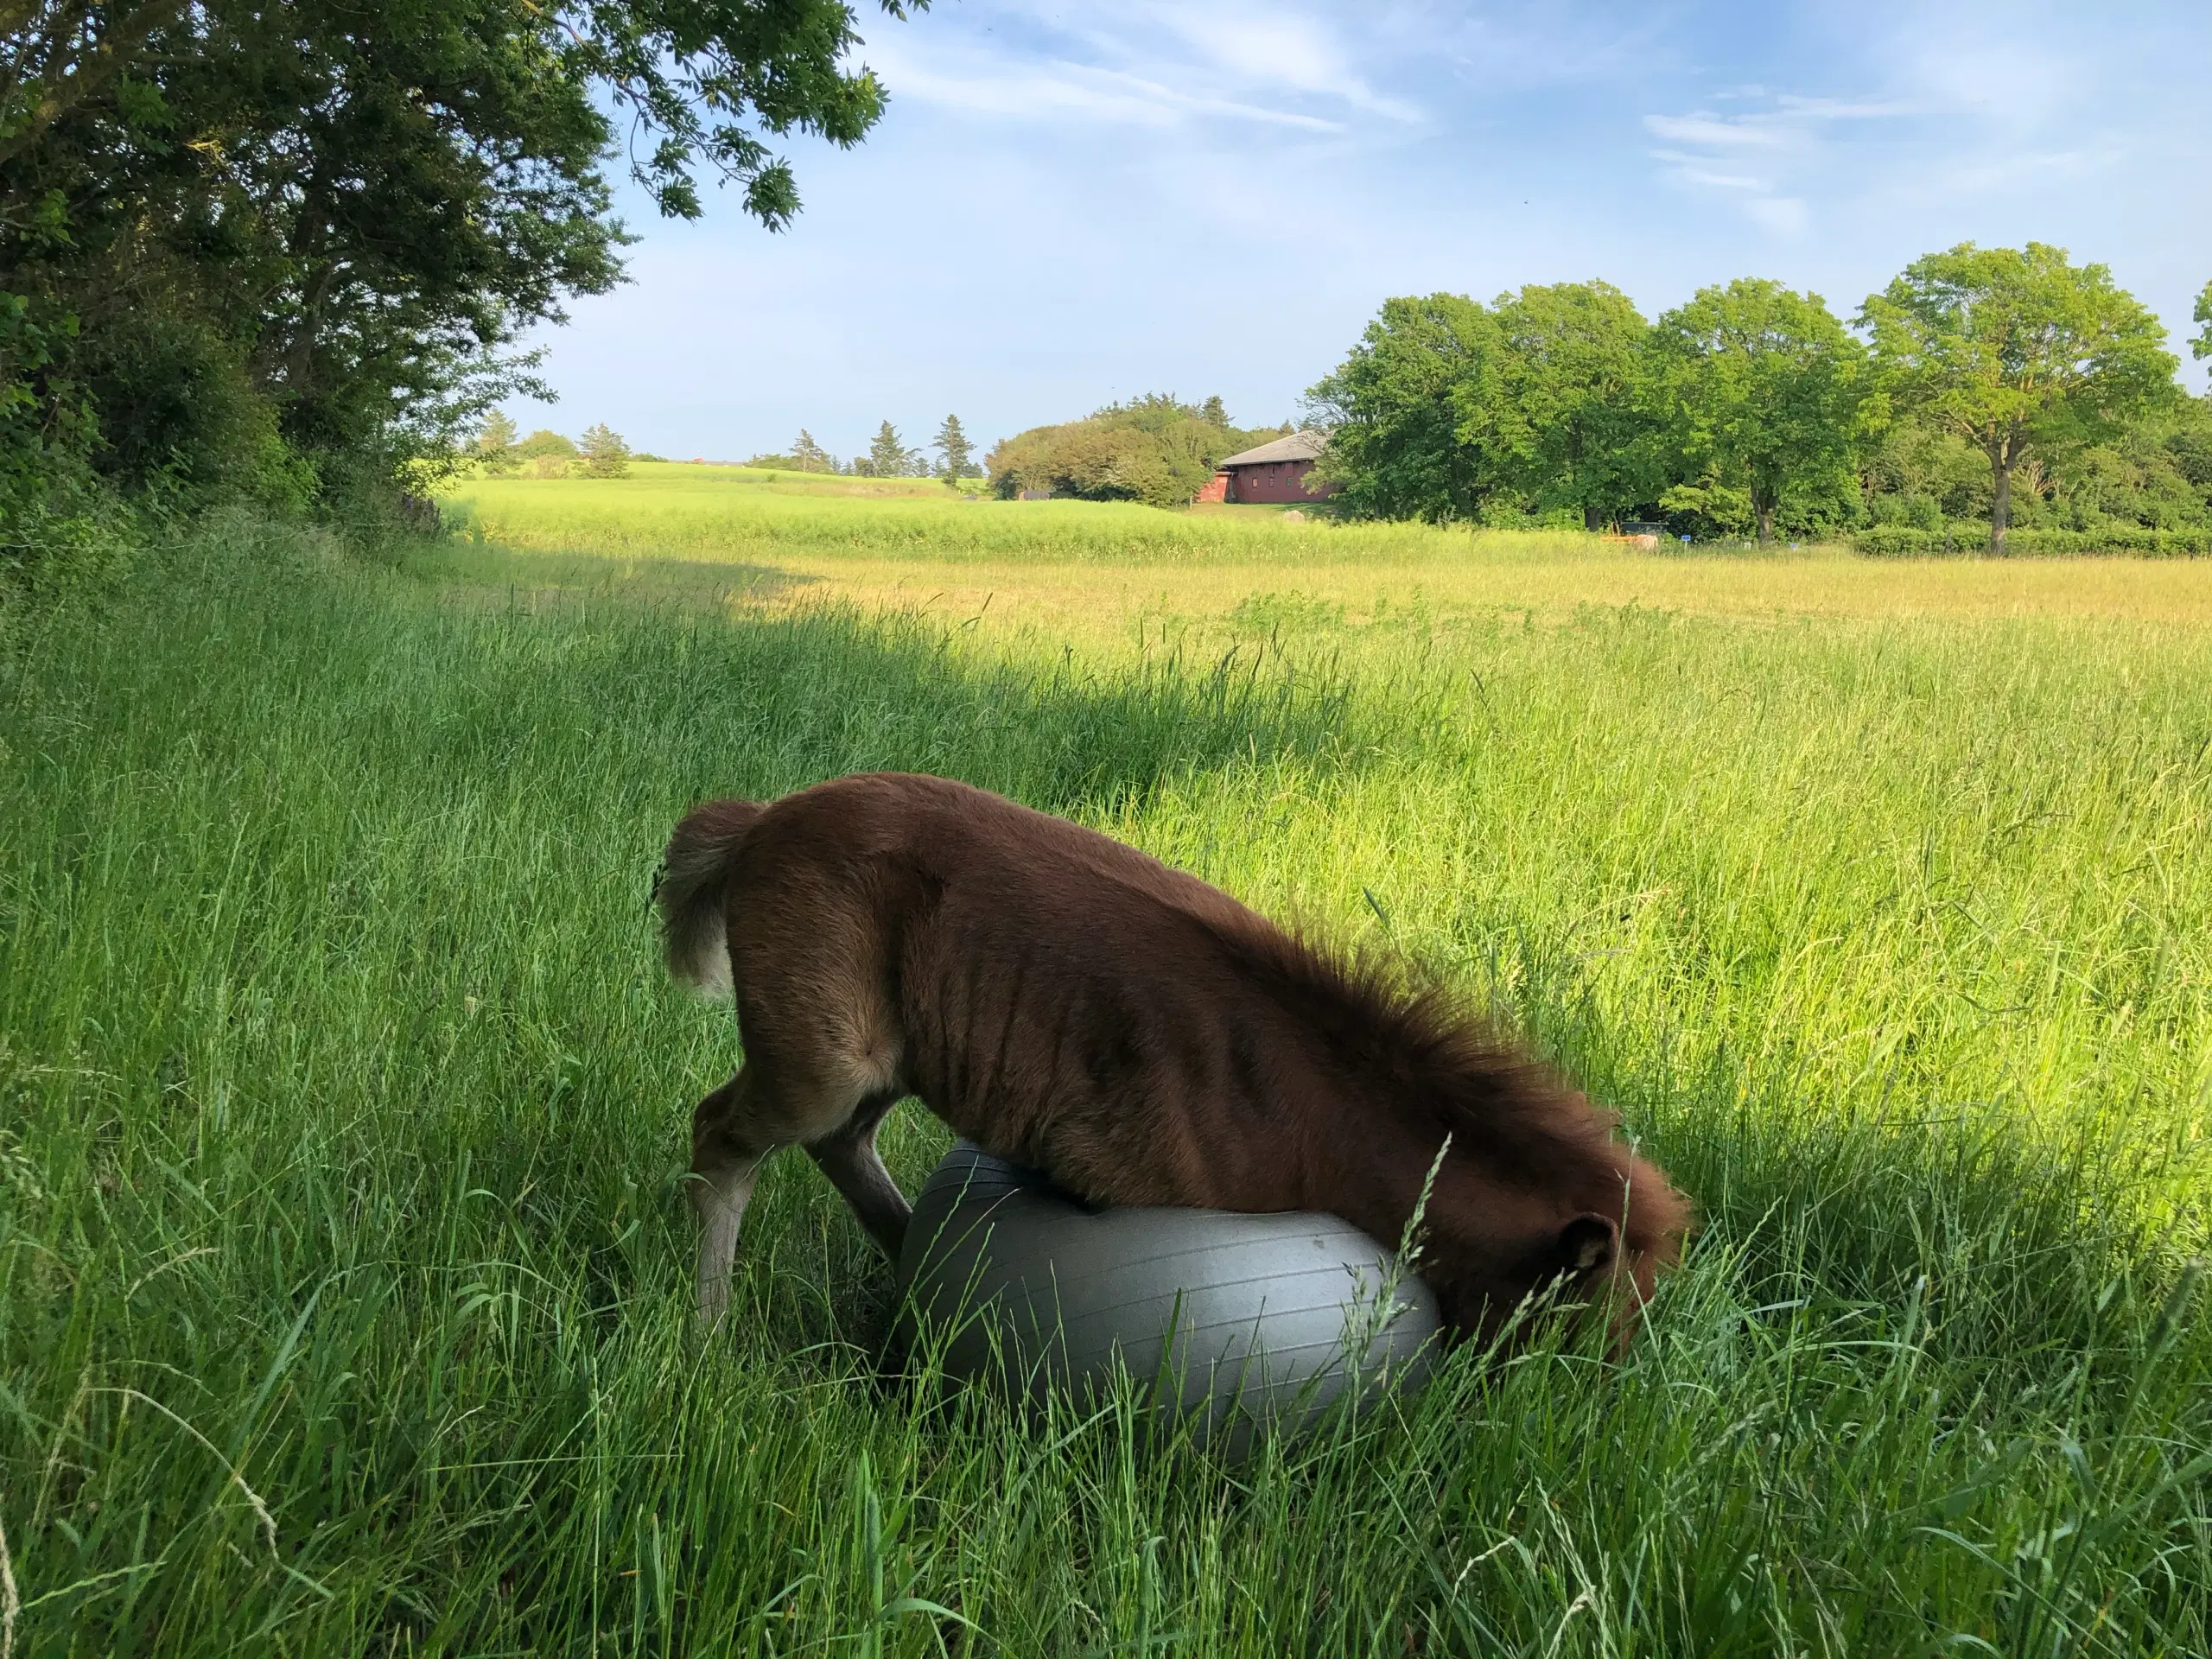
[513,0,2212,468]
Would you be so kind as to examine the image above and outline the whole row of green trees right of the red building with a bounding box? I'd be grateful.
[1307,244,2212,550]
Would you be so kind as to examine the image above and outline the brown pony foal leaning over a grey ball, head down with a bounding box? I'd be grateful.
[657,772,1688,1338]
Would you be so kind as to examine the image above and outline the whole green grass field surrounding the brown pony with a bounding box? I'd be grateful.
[13,486,2212,1656]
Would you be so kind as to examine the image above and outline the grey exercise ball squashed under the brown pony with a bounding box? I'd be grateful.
[898,1141,1438,1458]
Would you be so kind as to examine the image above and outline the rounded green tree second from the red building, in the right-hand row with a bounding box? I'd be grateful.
[1453,283,1650,531]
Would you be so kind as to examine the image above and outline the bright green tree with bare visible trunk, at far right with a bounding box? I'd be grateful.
[1860,241,2179,556]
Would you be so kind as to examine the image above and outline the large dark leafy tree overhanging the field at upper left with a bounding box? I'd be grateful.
[0,0,913,506]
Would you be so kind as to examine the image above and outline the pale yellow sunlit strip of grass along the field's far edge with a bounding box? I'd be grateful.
[447,467,2212,641]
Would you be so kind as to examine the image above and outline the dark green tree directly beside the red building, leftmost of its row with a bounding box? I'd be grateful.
[1307,294,1497,522]
